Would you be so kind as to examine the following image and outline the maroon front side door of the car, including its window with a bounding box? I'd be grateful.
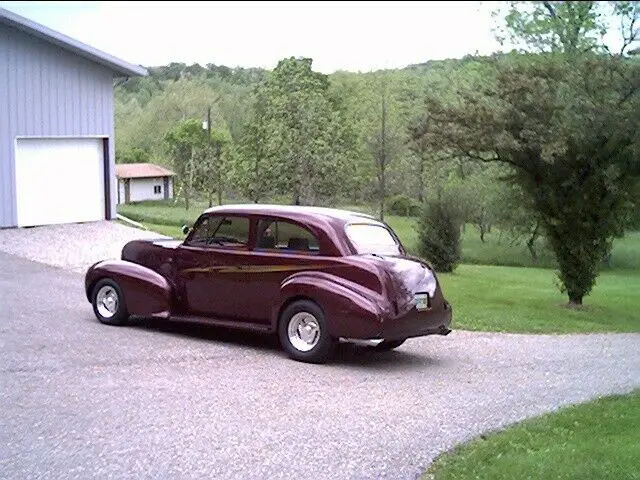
[176,214,250,320]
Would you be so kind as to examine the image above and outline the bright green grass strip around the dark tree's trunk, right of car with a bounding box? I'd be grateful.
[438,265,640,333]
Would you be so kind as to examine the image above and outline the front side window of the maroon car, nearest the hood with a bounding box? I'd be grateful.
[189,216,249,247]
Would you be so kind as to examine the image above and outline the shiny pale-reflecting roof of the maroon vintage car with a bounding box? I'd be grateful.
[204,204,382,225]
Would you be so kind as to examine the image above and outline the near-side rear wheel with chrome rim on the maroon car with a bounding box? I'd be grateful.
[278,300,336,363]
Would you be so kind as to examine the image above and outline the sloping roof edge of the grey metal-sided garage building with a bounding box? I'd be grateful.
[0,7,147,77]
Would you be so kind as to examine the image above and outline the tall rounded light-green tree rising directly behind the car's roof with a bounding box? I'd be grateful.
[255,57,350,205]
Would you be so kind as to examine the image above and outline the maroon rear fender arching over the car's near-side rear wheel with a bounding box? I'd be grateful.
[272,272,388,338]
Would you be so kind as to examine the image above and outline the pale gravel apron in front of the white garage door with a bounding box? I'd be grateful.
[0,220,167,273]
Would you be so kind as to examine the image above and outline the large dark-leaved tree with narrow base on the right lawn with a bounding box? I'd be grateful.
[416,55,640,305]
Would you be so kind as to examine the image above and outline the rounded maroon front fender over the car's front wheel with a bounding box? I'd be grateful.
[85,260,173,317]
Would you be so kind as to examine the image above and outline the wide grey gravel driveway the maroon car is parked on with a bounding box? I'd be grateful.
[0,253,640,480]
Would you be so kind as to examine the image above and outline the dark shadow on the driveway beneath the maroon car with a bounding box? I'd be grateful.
[128,318,439,370]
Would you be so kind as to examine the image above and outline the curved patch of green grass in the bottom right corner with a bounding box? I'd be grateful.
[422,390,640,480]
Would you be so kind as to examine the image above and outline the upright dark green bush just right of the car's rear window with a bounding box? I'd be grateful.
[417,198,462,272]
